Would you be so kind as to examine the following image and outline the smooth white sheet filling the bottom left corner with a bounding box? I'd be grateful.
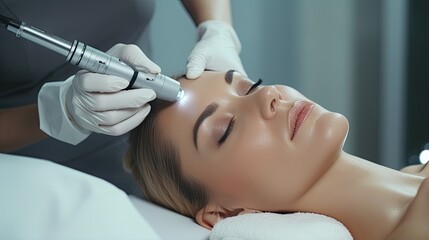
[0,153,160,240]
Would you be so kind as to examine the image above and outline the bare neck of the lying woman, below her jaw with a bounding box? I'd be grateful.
[288,152,423,240]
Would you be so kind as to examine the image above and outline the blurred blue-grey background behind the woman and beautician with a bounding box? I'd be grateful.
[141,0,429,169]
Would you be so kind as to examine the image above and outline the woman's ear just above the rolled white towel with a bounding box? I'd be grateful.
[195,203,260,230]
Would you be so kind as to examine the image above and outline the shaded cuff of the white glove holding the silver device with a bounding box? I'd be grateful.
[38,76,91,145]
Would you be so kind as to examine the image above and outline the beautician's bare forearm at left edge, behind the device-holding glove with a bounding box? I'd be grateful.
[0,104,48,152]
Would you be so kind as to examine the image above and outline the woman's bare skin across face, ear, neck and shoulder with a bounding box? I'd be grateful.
[158,72,429,239]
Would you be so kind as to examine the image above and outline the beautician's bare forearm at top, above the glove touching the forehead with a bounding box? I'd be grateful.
[182,0,232,25]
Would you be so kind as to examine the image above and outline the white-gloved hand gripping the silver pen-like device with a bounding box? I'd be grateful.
[38,44,161,144]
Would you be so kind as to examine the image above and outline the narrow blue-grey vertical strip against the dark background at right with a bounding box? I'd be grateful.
[379,0,408,169]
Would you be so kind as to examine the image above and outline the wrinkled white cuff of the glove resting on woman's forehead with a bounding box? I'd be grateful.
[197,20,241,53]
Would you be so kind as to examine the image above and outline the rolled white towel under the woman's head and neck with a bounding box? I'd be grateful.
[210,213,353,240]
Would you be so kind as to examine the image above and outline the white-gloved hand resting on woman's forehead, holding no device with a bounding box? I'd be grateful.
[186,20,247,79]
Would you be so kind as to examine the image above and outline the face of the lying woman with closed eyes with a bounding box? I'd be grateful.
[159,72,348,211]
